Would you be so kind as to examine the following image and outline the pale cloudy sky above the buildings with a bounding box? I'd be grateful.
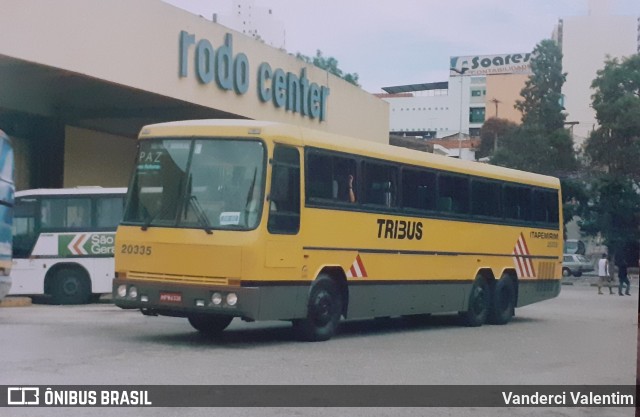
[162,0,640,93]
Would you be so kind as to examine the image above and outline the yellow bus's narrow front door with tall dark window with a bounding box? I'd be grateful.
[265,144,302,280]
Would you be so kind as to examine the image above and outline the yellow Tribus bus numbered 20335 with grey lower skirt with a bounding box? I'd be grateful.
[113,120,562,341]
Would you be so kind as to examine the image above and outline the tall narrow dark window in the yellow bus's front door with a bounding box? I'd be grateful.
[267,145,300,234]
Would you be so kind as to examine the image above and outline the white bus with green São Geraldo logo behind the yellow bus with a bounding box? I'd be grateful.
[9,187,127,304]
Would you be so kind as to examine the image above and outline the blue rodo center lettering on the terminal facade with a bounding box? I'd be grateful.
[179,30,330,121]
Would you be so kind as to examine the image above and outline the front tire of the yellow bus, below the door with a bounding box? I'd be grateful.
[293,274,342,342]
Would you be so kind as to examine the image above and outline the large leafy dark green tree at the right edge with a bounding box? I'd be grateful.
[580,54,640,261]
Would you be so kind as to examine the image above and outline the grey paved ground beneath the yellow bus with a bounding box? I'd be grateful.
[0,279,638,417]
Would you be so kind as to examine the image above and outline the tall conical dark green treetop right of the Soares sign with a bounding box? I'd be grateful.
[515,39,567,132]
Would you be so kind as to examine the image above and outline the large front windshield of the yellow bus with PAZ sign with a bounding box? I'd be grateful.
[124,139,265,231]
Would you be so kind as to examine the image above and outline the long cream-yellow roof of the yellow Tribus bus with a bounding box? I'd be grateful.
[140,119,560,188]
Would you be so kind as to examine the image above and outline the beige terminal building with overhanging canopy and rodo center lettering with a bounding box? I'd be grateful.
[0,0,389,189]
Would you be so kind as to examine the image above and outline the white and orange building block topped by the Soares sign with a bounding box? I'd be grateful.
[378,53,531,159]
